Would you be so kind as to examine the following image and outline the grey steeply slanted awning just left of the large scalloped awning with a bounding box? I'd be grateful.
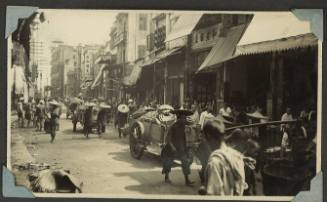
[197,24,246,72]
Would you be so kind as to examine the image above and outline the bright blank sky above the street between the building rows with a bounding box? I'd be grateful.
[40,9,117,46]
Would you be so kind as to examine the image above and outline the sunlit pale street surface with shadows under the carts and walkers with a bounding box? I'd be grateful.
[12,116,199,194]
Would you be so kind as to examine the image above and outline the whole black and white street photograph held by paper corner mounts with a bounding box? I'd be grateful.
[7,8,322,200]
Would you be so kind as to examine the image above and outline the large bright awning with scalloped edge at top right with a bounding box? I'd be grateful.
[236,12,318,55]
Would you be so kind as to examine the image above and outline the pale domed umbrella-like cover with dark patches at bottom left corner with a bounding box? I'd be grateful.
[29,169,83,193]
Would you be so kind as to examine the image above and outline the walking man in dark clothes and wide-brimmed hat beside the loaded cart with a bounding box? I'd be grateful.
[161,110,194,186]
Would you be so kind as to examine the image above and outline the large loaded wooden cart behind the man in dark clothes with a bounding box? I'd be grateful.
[129,105,201,159]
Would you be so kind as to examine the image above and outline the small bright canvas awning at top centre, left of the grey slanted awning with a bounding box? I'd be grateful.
[165,14,203,42]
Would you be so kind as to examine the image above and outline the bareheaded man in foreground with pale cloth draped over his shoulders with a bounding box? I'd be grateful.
[199,120,247,195]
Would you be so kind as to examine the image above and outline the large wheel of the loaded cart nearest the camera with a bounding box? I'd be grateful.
[129,125,145,159]
